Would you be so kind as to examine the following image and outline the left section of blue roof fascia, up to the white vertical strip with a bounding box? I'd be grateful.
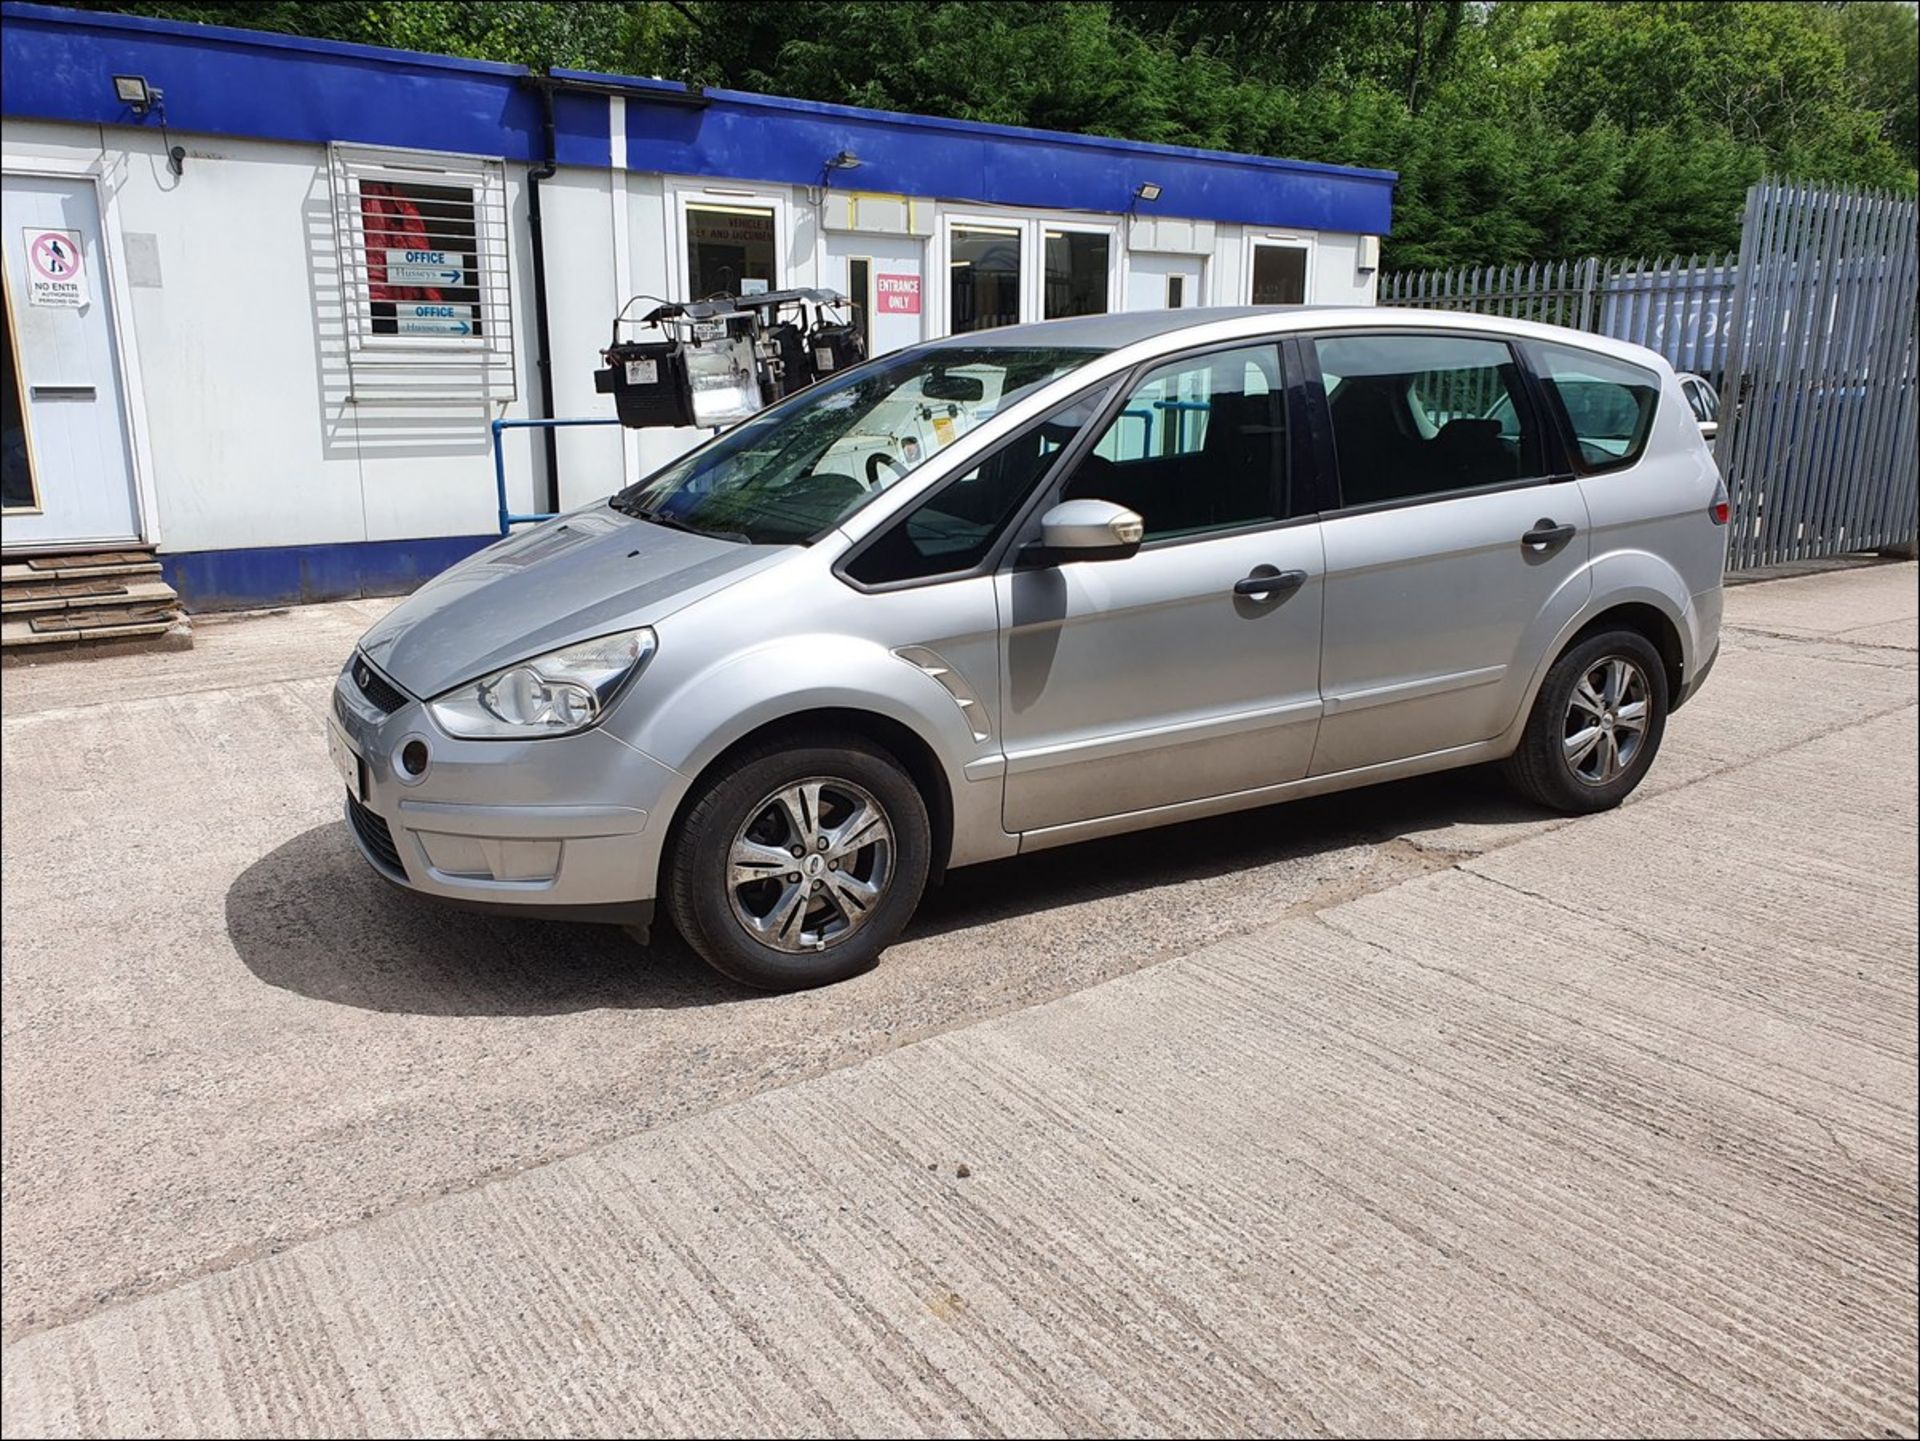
[0,4,611,167]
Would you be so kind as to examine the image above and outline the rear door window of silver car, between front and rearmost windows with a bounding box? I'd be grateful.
[1317,336,1544,505]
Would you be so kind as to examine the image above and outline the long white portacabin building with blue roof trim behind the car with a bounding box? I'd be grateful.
[0,4,1394,639]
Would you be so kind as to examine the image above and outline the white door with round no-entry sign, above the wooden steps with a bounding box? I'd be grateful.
[0,175,140,551]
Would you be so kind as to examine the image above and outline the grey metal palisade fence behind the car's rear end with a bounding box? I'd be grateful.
[1380,182,1920,570]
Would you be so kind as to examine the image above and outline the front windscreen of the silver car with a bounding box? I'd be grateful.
[611,345,1100,545]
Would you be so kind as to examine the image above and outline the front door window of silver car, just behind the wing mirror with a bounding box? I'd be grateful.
[1064,345,1286,541]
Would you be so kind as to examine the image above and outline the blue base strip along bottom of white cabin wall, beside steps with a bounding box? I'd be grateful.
[159,535,499,614]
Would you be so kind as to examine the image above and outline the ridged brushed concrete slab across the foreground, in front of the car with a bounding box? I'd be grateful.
[6,714,1916,1435]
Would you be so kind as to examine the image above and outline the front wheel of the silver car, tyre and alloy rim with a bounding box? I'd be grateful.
[666,735,933,990]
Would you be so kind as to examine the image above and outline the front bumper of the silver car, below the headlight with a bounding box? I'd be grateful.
[326,660,682,923]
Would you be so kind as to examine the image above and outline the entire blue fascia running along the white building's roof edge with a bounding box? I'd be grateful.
[0,0,1396,234]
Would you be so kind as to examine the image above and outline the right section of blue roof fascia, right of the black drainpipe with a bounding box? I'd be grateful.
[555,71,1398,236]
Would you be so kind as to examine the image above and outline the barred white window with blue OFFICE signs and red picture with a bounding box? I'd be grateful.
[326,144,515,401]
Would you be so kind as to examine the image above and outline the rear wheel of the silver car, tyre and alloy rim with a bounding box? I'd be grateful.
[1503,629,1667,815]
